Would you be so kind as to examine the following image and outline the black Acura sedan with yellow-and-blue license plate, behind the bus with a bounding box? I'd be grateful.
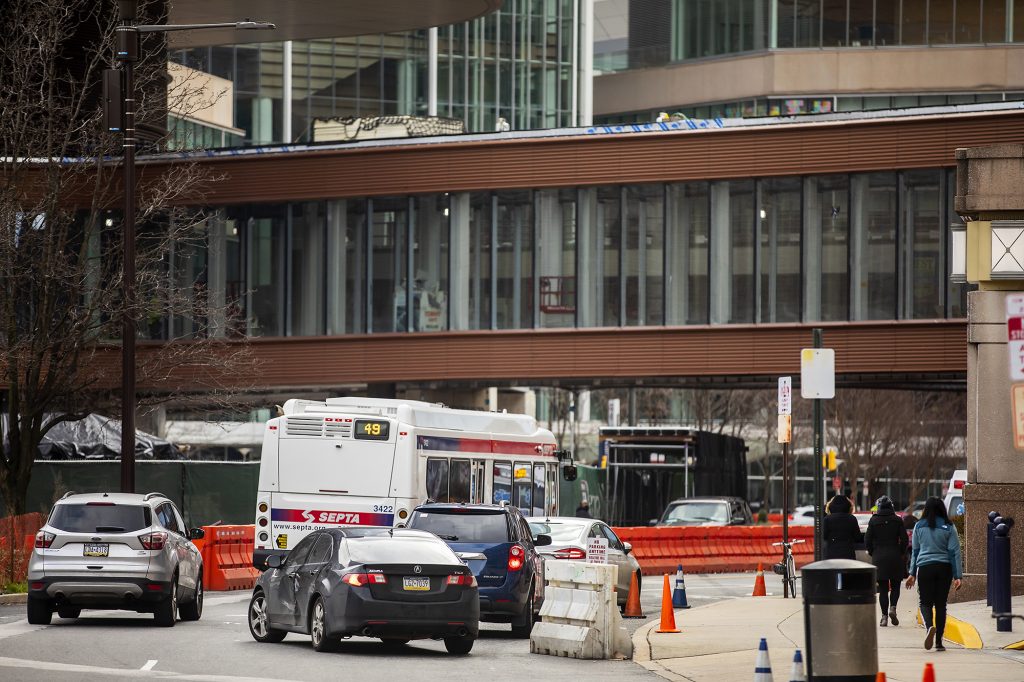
[249,527,480,654]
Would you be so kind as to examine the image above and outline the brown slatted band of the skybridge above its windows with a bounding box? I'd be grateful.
[145,111,1024,206]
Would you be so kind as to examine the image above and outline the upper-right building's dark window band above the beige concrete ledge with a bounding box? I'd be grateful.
[594,0,1024,72]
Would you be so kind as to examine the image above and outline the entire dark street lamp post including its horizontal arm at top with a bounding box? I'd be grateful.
[103,0,274,493]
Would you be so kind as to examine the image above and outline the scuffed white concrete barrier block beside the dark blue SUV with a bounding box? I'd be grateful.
[529,560,633,658]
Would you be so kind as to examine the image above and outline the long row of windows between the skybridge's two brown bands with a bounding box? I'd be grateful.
[155,169,967,337]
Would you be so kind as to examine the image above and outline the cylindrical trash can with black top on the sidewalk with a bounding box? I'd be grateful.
[801,559,879,682]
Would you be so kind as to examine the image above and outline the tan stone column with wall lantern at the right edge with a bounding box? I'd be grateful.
[955,144,1024,600]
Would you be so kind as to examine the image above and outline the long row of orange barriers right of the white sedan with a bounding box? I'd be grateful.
[614,525,814,576]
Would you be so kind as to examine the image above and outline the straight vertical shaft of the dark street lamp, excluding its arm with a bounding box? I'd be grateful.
[116,0,138,493]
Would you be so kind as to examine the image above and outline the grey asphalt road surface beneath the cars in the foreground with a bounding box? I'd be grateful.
[0,573,777,682]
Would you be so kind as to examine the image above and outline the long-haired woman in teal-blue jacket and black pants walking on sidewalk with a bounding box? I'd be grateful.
[906,498,964,651]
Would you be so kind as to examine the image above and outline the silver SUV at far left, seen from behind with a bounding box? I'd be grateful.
[28,493,204,627]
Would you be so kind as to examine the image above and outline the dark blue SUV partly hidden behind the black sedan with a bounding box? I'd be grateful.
[409,503,551,637]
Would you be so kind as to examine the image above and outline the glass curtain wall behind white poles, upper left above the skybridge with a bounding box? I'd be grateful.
[171,0,578,144]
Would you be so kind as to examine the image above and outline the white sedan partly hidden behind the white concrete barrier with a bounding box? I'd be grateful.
[528,516,641,608]
